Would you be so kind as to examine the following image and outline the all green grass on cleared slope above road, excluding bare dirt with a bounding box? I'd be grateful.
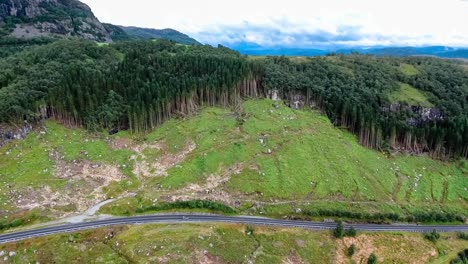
[0,100,468,225]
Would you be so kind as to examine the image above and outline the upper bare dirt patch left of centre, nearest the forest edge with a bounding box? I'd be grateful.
[132,141,197,177]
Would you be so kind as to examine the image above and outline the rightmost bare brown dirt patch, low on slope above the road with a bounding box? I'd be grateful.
[168,163,244,207]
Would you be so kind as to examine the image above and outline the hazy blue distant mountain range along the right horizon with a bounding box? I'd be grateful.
[227,43,468,59]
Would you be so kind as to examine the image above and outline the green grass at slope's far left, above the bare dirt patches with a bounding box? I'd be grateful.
[0,121,138,219]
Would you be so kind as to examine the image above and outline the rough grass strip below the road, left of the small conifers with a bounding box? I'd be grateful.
[0,224,334,263]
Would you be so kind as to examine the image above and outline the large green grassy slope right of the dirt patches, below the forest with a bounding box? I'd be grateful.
[133,100,468,216]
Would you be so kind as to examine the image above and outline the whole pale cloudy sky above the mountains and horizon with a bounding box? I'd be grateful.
[82,0,468,49]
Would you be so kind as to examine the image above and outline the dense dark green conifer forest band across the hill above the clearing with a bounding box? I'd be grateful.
[0,40,468,157]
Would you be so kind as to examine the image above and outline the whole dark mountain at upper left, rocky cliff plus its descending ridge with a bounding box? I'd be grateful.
[0,0,200,45]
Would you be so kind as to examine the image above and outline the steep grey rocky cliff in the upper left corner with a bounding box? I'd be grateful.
[0,0,111,42]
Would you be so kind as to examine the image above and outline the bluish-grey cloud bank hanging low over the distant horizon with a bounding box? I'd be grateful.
[192,19,468,49]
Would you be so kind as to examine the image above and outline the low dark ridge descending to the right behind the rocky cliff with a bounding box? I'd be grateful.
[116,26,201,45]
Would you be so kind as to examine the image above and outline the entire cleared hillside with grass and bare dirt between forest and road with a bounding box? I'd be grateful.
[0,99,468,229]
